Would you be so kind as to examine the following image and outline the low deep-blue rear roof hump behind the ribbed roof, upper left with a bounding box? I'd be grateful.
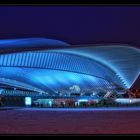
[0,38,69,52]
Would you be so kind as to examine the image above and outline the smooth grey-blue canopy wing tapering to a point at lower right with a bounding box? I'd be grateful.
[59,45,140,88]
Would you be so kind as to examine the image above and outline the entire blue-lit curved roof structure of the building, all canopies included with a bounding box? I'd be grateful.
[0,38,140,94]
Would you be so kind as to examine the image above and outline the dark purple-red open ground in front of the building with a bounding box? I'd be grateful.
[0,108,140,134]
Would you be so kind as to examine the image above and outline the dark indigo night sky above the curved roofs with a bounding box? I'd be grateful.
[0,6,140,87]
